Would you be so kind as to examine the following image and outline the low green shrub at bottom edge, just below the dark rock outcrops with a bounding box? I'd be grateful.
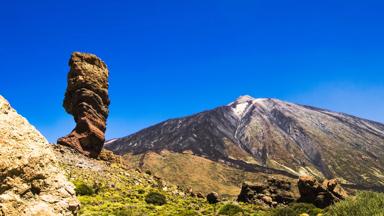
[271,203,322,216]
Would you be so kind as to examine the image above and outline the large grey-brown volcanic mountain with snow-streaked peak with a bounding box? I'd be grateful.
[106,96,384,190]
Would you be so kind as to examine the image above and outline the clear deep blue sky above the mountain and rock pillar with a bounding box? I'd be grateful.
[0,0,384,141]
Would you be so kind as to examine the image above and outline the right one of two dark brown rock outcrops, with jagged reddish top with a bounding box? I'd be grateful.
[298,176,348,208]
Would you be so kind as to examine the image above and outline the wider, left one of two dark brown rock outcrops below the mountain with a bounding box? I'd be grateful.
[237,178,296,207]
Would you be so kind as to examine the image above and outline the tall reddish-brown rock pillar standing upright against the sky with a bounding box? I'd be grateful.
[57,52,110,158]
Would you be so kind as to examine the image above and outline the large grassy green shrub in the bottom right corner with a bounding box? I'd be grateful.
[327,192,384,216]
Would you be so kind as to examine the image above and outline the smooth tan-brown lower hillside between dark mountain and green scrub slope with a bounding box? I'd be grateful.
[124,150,298,197]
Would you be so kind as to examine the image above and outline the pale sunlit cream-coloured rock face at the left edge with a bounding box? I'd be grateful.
[0,96,79,216]
